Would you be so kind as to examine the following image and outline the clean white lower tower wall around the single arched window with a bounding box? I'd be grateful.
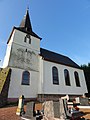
[8,68,39,98]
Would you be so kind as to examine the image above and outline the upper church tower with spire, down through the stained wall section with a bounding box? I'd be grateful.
[3,9,41,71]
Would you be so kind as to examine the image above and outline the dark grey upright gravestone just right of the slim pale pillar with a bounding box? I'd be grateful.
[22,102,36,120]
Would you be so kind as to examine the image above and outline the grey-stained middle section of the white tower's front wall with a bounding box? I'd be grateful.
[9,44,39,71]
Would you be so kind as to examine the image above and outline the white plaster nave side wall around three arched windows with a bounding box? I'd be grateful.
[43,60,87,95]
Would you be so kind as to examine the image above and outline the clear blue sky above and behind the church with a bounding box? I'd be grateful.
[0,0,90,66]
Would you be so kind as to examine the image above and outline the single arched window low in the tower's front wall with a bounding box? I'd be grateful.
[22,71,30,85]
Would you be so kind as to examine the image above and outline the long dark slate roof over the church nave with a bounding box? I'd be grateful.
[40,48,80,69]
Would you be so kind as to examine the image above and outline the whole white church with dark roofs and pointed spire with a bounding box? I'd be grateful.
[0,10,87,104]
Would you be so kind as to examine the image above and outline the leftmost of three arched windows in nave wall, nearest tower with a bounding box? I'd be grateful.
[52,66,59,85]
